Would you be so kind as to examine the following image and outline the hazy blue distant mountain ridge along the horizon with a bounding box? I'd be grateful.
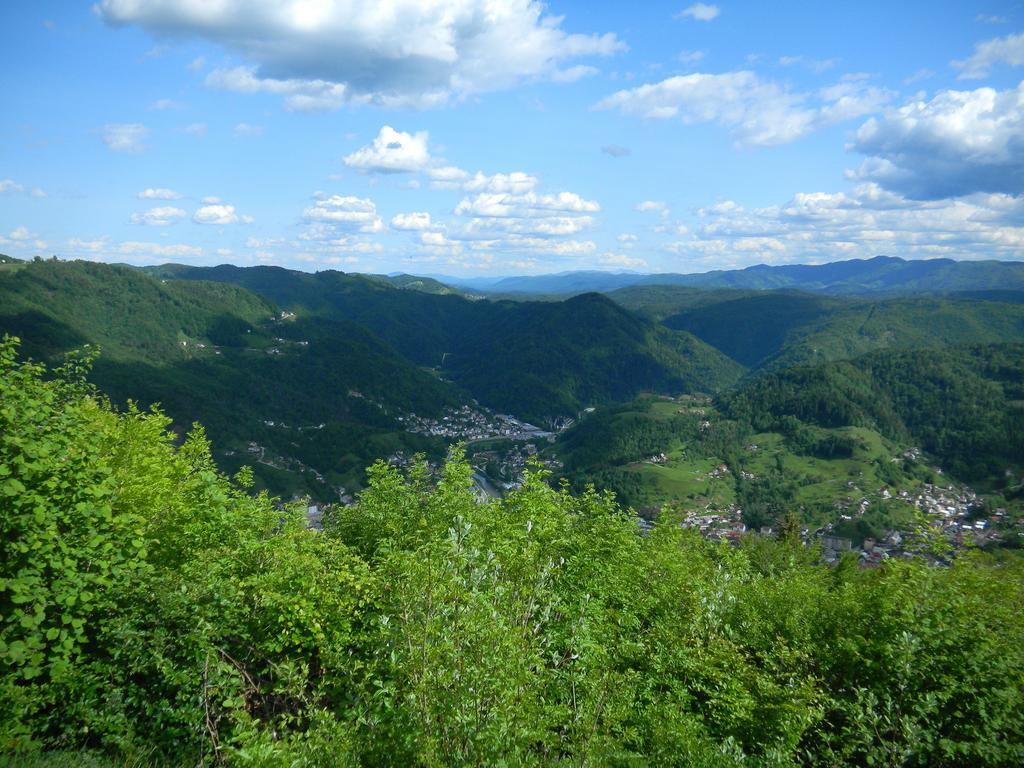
[437,256,1024,296]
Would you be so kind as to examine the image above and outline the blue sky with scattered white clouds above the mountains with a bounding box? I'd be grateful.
[0,0,1024,274]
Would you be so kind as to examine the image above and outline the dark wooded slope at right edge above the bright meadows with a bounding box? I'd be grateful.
[722,344,1024,487]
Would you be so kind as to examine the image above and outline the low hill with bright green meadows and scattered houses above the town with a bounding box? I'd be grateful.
[551,396,935,541]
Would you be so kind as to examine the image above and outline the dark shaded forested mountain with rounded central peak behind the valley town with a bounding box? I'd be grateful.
[146,266,741,422]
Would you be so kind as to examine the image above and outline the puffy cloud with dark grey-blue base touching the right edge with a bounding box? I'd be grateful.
[852,83,1024,200]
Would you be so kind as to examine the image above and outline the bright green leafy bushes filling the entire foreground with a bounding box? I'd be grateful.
[0,342,1024,766]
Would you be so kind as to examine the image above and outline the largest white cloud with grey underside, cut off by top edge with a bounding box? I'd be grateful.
[96,0,622,110]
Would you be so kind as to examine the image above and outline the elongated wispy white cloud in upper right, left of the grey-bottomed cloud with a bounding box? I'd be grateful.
[595,71,893,146]
